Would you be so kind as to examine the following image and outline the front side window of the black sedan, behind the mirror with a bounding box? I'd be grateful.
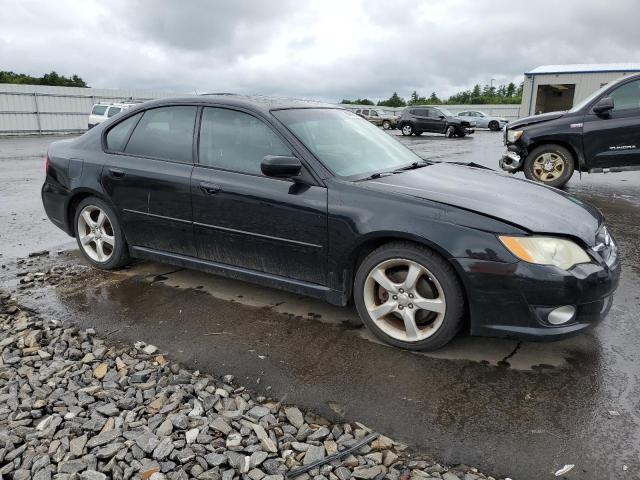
[199,107,293,175]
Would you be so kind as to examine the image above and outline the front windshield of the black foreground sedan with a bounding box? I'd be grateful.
[273,108,422,178]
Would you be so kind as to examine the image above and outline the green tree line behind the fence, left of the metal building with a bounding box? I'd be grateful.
[340,82,522,107]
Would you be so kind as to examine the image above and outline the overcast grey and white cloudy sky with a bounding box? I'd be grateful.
[0,0,640,101]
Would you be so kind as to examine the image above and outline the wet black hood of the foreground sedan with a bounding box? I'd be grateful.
[365,162,603,245]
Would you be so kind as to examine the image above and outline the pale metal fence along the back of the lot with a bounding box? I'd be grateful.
[0,83,520,135]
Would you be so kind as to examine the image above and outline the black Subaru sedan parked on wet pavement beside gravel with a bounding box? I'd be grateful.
[42,95,620,350]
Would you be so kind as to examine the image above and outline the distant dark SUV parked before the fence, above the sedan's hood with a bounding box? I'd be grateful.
[398,106,476,138]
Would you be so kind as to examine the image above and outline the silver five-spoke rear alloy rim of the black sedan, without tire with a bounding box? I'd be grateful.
[78,205,116,263]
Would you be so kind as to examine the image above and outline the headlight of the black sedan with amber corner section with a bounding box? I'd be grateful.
[498,236,591,270]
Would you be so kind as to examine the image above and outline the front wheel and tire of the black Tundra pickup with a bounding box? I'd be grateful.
[523,144,575,188]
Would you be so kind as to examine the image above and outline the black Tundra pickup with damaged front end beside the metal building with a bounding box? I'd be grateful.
[500,74,640,188]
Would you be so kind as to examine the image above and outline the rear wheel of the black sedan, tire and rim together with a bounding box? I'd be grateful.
[73,197,129,270]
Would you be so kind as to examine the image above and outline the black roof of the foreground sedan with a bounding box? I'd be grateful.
[133,93,344,113]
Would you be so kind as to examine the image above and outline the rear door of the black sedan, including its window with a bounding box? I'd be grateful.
[102,105,198,256]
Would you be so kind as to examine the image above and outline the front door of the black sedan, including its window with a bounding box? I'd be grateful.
[191,107,327,285]
